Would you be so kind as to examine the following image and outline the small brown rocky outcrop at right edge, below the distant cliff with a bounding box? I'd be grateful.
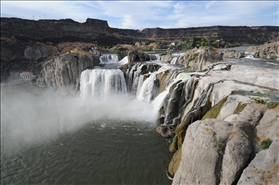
[245,42,279,59]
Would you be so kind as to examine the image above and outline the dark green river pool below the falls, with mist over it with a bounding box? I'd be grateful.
[1,84,171,185]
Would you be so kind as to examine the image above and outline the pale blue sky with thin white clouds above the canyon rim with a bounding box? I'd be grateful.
[1,0,279,30]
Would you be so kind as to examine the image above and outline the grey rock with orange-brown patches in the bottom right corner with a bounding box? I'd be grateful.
[237,139,279,185]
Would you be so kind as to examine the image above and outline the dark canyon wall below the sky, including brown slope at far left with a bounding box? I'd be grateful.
[1,18,279,81]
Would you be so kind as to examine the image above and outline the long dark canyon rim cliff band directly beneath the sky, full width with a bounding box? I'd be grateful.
[1,18,279,45]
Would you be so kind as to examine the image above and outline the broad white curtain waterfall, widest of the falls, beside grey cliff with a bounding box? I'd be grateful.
[80,69,127,99]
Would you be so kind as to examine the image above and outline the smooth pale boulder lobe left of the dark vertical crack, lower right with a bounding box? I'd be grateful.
[172,119,232,185]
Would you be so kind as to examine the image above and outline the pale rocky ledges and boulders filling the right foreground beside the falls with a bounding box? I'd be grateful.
[121,43,279,185]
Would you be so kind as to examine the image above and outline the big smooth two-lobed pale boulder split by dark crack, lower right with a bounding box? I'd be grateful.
[173,104,264,184]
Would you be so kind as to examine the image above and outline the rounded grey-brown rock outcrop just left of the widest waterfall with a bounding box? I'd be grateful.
[37,53,99,95]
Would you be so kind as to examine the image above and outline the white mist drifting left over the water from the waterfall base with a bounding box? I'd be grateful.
[1,84,160,154]
